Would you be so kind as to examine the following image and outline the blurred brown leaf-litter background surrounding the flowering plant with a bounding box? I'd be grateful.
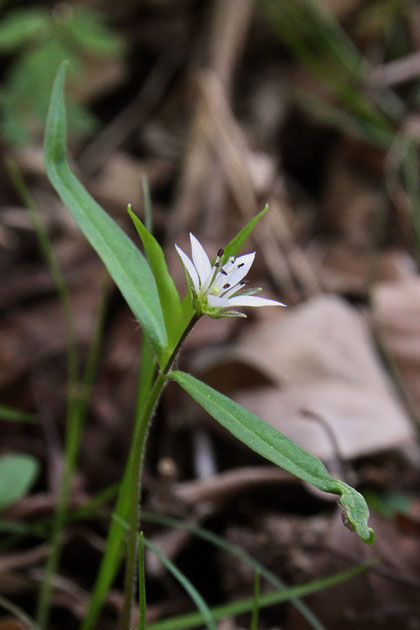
[0,0,420,630]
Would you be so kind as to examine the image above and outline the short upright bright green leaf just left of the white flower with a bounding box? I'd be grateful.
[128,206,183,349]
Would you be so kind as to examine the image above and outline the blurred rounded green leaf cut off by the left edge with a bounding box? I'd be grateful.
[0,453,39,510]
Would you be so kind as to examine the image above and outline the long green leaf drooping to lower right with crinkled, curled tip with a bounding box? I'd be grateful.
[170,371,375,544]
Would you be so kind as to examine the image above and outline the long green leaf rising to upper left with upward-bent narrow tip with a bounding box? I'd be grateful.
[45,64,168,358]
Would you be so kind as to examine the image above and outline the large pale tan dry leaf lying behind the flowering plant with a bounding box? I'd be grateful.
[193,296,414,459]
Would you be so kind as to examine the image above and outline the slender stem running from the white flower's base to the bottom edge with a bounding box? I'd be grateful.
[121,313,200,630]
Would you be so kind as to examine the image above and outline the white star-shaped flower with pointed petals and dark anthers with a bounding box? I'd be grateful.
[175,234,285,317]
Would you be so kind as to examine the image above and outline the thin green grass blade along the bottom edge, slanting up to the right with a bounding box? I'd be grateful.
[146,564,370,630]
